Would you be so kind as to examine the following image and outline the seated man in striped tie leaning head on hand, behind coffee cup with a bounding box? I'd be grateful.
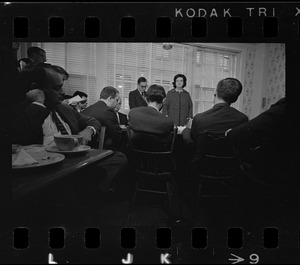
[11,64,127,192]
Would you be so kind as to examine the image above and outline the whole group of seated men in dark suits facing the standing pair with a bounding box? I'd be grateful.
[12,60,285,199]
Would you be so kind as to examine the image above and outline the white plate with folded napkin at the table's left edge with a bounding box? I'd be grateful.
[12,146,65,169]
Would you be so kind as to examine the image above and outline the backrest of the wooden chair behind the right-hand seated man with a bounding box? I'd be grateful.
[196,131,239,178]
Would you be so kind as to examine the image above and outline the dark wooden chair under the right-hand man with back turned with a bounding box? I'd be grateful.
[192,131,240,214]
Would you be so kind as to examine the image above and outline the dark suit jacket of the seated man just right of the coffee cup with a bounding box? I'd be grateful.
[82,100,126,150]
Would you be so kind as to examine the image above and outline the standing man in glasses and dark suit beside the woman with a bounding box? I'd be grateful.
[129,77,147,109]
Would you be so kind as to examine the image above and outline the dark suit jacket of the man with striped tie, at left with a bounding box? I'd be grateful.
[12,102,100,145]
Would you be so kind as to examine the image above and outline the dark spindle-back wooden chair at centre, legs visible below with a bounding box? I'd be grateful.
[127,127,177,223]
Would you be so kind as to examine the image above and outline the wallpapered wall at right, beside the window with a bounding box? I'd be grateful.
[242,43,285,119]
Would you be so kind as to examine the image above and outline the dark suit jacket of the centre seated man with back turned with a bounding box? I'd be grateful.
[128,107,174,151]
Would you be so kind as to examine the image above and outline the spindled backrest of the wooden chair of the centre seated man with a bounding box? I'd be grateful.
[127,127,177,176]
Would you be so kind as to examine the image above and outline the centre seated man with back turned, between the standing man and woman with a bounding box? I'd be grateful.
[128,85,174,150]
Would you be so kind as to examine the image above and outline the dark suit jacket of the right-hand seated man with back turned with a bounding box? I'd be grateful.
[191,103,248,141]
